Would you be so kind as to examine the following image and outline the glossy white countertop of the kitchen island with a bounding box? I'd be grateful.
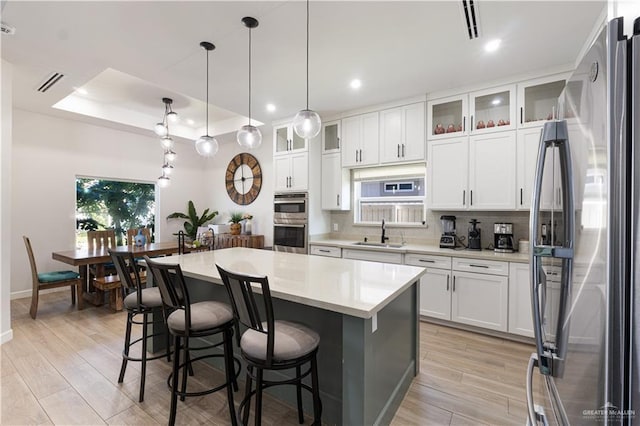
[146,247,425,318]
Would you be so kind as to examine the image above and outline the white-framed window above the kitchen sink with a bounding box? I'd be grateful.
[353,165,425,225]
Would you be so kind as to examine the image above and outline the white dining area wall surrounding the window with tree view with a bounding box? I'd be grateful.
[10,108,209,298]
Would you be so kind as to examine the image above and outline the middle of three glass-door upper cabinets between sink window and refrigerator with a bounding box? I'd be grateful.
[469,84,516,134]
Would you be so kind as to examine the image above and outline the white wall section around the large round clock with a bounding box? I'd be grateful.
[205,125,274,247]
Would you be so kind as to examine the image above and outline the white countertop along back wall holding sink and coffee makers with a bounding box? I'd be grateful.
[309,239,529,263]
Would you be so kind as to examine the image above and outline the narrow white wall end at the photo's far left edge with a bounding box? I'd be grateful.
[0,61,13,344]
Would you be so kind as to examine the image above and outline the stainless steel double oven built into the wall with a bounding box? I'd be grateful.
[273,192,309,254]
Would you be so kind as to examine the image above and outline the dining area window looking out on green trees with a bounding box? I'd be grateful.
[76,177,156,247]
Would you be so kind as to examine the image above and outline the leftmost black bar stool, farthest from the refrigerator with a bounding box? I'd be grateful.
[109,249,171,402]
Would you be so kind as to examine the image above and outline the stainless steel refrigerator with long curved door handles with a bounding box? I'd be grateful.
[527,18,640,425]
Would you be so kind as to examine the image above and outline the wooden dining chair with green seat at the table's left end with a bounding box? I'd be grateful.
[22,235,83,319]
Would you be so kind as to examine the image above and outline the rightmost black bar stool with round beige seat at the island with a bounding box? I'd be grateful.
[216,265,322,425]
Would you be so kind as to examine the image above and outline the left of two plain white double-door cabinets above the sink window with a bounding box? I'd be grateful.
[341,112,380,167]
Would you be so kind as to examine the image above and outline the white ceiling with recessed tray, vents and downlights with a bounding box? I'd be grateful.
[1,0,604,138]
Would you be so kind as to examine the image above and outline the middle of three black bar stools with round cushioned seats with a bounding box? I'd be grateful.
[144,256,240,425]
